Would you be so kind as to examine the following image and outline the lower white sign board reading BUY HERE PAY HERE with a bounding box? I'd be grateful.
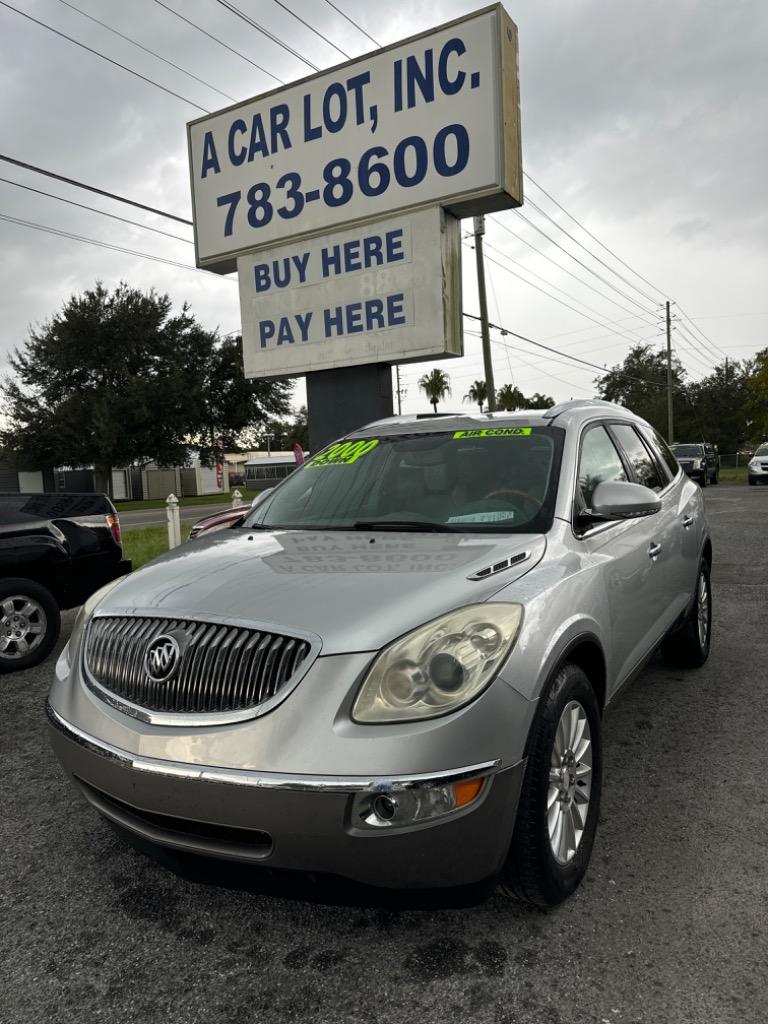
[238,207,462,377]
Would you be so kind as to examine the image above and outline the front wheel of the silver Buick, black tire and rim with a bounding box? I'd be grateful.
[501,665,602,907]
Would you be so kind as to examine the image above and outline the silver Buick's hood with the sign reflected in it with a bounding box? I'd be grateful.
[97,529,547,654]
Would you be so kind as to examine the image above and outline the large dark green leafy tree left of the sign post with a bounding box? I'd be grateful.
[0,284,289,489]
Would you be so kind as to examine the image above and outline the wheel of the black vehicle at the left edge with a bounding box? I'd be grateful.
[0,579,61,673]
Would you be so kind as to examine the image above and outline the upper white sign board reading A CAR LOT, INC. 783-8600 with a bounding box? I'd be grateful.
[187,4,522,272]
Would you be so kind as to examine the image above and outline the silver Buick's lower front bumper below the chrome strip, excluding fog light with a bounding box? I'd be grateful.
[47,705,525,888]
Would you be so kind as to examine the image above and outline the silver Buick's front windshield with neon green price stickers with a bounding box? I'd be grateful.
[244,427,563,534]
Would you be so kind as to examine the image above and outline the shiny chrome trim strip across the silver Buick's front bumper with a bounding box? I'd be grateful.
[45,700,501,794]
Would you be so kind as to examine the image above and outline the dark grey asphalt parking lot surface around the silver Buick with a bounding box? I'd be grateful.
[0,484,768,1024]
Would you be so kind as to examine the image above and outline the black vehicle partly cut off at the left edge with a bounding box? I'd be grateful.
[0,494,131,673]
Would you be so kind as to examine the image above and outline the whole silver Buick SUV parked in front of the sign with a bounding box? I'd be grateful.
[48,401,712,906]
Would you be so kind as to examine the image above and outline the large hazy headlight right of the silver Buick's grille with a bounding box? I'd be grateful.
[352,602,522,724]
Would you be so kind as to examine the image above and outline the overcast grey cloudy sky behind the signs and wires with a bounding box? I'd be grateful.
[0,0,768,411]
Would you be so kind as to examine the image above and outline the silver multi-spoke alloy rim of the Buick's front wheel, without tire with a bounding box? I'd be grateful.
[547,700,592,864]
